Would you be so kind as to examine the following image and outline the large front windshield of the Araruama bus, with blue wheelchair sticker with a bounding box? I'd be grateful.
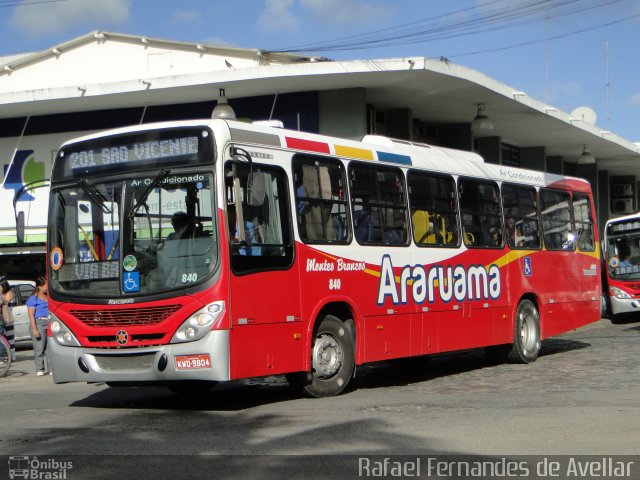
[49,170,218,299]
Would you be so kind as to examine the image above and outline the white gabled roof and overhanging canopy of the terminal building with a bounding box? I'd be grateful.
[0,32,640,175]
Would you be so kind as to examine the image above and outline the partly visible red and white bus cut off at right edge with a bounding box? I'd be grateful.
[602,213,640,321]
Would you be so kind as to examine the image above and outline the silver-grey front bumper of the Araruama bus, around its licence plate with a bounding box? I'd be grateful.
[47,330,230,383]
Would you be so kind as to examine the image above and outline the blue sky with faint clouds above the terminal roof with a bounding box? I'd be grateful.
[0,0,640,142]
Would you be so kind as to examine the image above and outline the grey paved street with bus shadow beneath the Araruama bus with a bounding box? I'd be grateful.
[0,320,640,475]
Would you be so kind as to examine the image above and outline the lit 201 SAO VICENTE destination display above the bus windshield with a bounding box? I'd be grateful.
[68,136,198,170]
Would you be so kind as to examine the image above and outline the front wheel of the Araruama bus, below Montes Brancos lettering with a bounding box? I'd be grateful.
[297,315,356,398]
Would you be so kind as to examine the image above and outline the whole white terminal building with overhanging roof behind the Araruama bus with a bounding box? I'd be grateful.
[0,32,640,278]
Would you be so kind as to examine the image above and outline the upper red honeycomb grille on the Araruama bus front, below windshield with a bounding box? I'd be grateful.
[69,305,180,327]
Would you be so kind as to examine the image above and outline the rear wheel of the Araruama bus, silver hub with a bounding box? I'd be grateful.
[507,298,541,363]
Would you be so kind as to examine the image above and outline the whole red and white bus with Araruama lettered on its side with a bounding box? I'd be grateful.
[48,120,601,397]
